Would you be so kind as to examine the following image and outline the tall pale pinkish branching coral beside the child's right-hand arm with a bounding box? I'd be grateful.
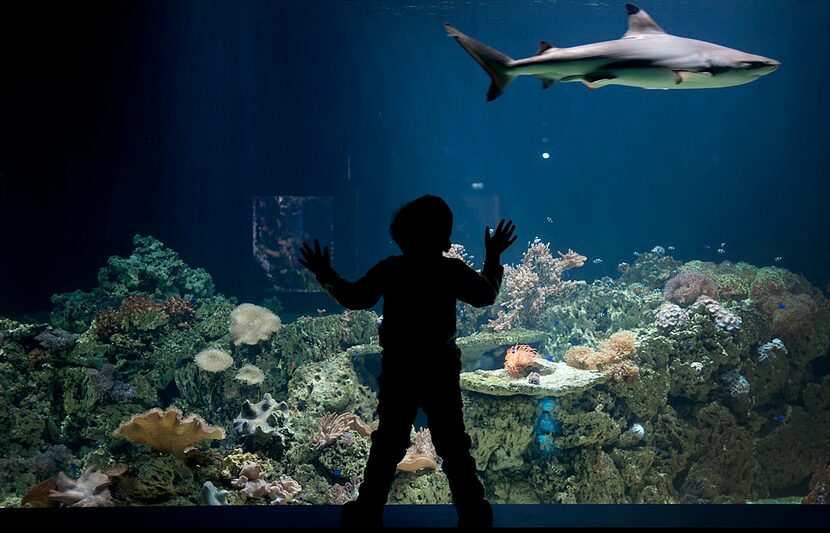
[488,242,587,331]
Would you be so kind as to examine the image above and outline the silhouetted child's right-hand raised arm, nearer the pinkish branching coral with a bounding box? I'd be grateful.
[457,219,518,307]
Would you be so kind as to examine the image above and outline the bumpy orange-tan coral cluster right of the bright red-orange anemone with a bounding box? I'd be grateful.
[565,331,639,381]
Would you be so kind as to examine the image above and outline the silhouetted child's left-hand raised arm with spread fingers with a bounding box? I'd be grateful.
[298,239,383,309]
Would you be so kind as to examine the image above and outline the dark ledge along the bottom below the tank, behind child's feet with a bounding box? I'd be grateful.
[0,505,830,529]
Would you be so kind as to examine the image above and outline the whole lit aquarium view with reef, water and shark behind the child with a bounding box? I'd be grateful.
[0,0,830,507]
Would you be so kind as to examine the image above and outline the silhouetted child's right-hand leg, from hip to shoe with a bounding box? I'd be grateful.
[423,364,493,527]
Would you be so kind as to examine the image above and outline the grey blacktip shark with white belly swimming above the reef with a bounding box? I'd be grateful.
[444,4,780,102]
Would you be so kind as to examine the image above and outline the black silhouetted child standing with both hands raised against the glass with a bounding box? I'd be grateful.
[300,195,517,527]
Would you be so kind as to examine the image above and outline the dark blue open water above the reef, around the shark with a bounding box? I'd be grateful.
[0,0,830,314]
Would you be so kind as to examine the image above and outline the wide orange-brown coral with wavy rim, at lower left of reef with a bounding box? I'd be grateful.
[112,408,225,455]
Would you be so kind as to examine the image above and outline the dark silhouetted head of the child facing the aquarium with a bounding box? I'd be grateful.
[389,194,452,255]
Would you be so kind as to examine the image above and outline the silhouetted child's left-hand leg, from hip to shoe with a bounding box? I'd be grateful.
[342,366,418,526]
